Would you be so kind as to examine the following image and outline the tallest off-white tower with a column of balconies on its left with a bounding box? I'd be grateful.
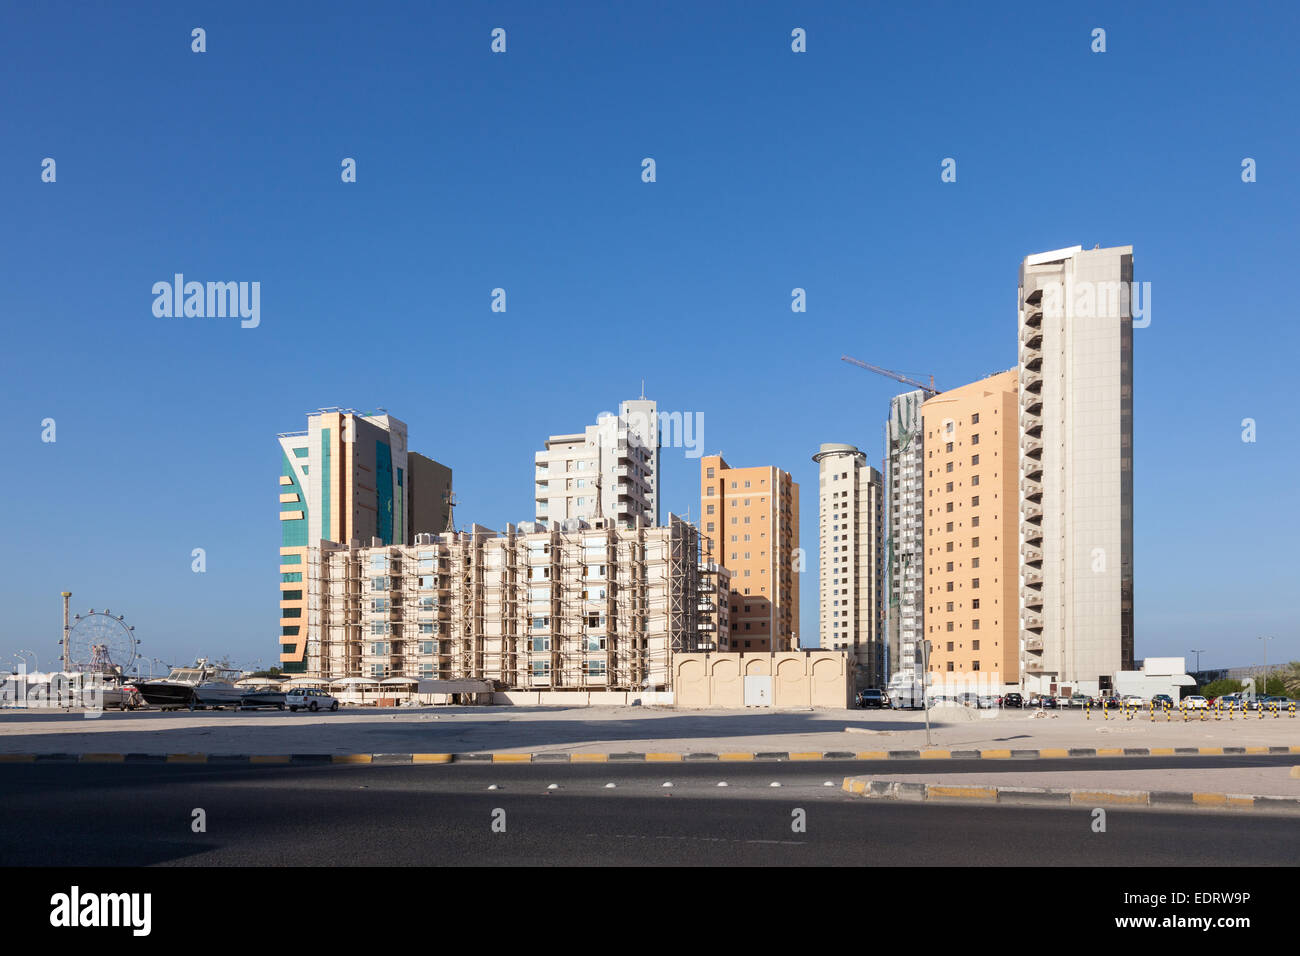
[1017,246,1135,692]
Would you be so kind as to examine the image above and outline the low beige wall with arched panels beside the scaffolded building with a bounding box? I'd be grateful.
[673,650,853,709]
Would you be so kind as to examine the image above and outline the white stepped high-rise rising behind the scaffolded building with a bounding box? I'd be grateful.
[533,399,659,527]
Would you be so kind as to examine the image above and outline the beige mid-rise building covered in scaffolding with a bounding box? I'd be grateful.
[306,515,727,691]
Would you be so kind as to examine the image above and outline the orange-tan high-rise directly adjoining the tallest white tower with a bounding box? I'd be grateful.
[920,369,1021,693]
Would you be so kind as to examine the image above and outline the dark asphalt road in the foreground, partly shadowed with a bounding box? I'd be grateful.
[0,756,1296,866]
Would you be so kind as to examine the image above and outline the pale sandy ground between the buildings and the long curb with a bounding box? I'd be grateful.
[0,706,1300,757]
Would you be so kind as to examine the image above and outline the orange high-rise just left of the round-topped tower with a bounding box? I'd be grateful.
[699,455,800,650]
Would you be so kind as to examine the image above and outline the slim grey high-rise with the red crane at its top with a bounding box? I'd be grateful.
[884,389,926,687]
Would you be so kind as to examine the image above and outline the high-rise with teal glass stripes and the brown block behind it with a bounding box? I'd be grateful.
[280,408,451,672]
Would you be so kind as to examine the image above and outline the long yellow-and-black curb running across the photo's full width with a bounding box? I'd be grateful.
[0,747,1300,766]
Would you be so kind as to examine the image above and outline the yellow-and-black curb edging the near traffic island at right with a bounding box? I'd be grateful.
[840,777,1300,813]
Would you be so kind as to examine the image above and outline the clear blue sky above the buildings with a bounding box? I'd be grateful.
[0,3,1300,666]
